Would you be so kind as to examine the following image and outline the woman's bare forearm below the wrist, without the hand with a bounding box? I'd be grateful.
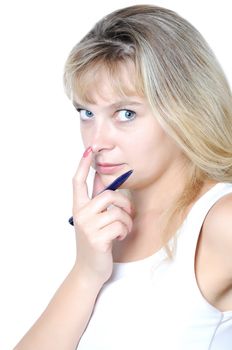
[14,266,101,350]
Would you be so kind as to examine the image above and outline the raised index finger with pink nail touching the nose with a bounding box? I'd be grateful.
[73,147,93,208]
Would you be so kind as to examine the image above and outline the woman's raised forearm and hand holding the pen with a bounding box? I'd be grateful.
[14,148,132,350]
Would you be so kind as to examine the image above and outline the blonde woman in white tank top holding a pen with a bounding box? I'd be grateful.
[15,5,232,350]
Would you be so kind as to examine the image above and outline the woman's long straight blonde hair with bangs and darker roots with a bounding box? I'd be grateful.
[64,5,232,252]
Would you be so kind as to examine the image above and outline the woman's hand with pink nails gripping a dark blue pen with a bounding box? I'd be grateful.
[73,149,132,284]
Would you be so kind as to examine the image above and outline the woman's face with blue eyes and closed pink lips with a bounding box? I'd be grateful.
[74,65,187,189]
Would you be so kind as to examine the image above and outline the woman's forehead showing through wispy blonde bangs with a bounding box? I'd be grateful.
[73,63,144,104]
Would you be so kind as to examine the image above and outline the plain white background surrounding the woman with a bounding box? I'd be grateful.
[0,0,232,350]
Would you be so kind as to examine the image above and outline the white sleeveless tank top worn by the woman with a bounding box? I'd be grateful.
[78,183,232,350]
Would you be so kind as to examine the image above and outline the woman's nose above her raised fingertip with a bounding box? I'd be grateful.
[91,120,114,153]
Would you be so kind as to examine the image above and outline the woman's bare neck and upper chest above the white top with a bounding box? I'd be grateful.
[114,165,186,261]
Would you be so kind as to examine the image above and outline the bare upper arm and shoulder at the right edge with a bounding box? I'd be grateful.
[195,194,232,311]
